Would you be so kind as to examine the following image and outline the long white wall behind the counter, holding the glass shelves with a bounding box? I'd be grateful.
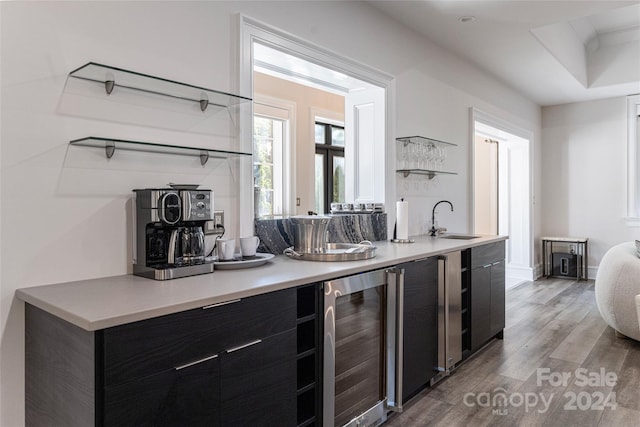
[0,1,540,427]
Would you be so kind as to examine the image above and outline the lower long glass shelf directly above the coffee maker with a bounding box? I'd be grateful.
[69,136,251,166]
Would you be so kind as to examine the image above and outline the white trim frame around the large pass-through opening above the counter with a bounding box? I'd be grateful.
[237,14,396,235]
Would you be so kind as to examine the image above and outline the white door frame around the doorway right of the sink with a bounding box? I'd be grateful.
[468,107,537,280]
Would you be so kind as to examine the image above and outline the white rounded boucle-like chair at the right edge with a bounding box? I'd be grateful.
[595,242,640,341]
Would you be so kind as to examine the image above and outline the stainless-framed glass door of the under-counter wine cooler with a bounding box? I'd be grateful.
[323,270,396,426]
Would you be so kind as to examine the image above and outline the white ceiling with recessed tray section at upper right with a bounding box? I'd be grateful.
[369,0,640,106]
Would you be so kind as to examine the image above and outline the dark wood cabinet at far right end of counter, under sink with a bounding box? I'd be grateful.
[469,242,505,351]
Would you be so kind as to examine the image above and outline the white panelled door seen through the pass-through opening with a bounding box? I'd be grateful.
[344,88,386,203]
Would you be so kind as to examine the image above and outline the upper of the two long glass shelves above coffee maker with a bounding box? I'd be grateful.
[69,62,251,111]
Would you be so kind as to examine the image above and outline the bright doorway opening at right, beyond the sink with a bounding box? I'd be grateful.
[471,110,535,288]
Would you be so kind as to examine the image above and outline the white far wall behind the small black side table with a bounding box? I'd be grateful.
[542,97,640,278]
